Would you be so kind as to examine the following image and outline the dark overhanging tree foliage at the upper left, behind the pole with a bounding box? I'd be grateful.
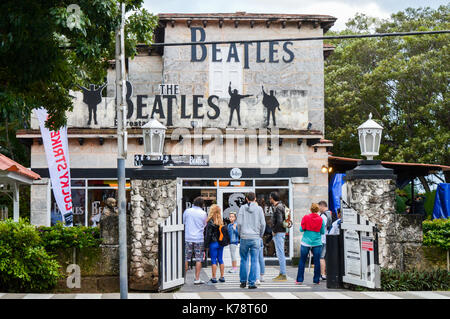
[0,0,157,129]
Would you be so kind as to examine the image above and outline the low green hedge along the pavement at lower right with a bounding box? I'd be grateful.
[381,268,450,291]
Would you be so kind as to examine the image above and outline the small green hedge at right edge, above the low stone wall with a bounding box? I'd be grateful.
[422,218,450,250]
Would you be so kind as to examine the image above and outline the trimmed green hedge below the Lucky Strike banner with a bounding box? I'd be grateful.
[38,223,102,252]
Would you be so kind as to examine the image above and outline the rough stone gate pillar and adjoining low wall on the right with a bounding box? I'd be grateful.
[347,179,422,271]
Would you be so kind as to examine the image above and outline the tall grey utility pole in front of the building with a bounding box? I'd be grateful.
[116,3,128,299]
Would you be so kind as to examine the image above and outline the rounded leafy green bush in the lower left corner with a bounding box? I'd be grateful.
[0,219,62,292]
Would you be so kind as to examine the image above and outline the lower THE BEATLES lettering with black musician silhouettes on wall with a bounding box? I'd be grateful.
[79,81,281,126]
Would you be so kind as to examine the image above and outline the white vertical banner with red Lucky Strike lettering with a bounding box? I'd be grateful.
[34,107,73,226]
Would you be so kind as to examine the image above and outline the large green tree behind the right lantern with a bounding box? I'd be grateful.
[325,5,450,165]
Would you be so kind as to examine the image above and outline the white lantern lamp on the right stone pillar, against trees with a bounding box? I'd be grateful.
[358,113,383,160]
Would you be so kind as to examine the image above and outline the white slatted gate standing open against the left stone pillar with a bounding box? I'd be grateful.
[158,209,185,291]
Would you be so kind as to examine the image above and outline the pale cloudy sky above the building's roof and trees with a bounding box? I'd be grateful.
[144,0,449,31]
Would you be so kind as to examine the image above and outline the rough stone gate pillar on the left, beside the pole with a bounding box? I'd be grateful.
[129,180,177,290]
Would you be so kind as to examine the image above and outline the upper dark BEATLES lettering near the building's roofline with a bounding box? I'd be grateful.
[191,27,295,69]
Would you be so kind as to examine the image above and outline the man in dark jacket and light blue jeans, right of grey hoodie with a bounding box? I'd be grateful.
[270,192,287,281]
